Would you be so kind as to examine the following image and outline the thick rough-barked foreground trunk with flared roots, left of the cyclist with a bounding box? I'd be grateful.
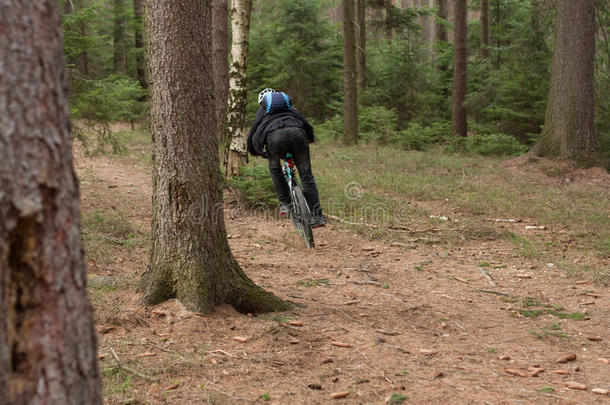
[139,0,288,313]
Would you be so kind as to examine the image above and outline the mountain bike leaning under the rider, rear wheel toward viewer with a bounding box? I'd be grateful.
[282,153,315,249]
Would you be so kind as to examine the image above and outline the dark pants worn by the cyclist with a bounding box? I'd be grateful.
[266,127,322,215]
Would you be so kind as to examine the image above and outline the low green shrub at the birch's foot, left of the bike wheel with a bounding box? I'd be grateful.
[227,166,279,208]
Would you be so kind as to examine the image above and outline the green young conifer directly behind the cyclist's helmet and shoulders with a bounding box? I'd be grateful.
[248,0,343,119]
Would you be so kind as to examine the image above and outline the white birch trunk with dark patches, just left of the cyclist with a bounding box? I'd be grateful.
[225,0,252,178]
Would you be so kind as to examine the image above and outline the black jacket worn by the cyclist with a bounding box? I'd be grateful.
[248,105,315,157]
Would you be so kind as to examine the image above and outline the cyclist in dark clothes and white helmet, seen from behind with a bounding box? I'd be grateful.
[248,88,326,227]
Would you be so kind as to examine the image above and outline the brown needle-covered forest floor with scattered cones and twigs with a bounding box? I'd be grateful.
[75,127,610,404]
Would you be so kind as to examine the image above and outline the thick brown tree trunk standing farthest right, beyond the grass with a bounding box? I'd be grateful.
[532,0,598,159]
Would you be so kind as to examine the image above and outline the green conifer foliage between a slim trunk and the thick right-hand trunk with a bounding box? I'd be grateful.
[467,0,552,143]
